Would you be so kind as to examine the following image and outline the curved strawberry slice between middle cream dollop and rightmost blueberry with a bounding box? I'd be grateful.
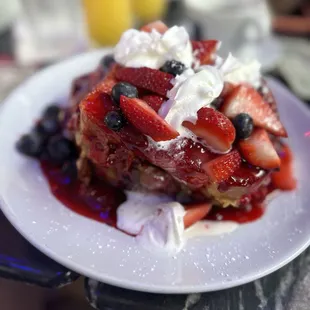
[183,108,236,153]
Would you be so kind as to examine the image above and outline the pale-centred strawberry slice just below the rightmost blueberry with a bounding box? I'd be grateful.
[239,128,280,169]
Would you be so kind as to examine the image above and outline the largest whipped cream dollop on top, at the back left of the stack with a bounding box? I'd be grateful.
[114,26,194,69]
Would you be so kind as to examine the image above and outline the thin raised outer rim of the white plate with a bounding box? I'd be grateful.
[0,48,310,294]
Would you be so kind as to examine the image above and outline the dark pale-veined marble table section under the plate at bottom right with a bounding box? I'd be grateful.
[85,250,310,310]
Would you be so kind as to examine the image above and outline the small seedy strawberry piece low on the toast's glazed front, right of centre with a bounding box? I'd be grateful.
[202,150,241,183]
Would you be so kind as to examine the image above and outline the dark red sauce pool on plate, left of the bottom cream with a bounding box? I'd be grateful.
[41,162,126,227]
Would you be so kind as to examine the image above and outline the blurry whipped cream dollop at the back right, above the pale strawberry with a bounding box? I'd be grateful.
[217,54,261,88]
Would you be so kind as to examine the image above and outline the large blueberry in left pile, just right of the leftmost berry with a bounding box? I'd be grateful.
[45,135,77,163]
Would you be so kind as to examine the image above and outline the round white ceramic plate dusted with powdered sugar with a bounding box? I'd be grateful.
[0,51,310,293]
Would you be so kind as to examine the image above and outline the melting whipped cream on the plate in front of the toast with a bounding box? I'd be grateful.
[117,191,238,255]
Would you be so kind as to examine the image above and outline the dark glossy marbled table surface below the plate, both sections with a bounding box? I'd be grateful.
[0,13,310,310]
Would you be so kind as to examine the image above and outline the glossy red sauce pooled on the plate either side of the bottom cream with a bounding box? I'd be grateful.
[41,162,264,227]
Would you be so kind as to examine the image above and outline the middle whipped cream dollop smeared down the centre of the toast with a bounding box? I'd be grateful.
[159,66,224,135]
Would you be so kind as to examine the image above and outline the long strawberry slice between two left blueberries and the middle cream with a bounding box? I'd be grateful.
[120,96,179,141]
